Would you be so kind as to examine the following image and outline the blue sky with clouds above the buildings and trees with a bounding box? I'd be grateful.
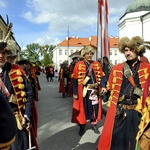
[0,0,134,47]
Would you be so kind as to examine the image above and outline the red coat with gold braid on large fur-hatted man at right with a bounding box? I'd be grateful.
[98,62,150,150]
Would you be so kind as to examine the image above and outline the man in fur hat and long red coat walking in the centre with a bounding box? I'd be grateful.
[71,45,106,136]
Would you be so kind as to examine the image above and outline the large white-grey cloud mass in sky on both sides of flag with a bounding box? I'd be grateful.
[15,0,134,43]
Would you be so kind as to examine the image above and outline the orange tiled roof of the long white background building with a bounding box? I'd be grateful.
[57,36,119,47]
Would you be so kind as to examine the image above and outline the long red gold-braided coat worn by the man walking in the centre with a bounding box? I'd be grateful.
[71,61,104,124]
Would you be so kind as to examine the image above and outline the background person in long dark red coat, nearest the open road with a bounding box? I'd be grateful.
[58,61,69,98]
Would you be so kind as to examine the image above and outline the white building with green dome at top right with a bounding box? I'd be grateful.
[118,0,150,61]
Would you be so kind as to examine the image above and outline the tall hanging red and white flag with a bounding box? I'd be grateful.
[97,0,110,59]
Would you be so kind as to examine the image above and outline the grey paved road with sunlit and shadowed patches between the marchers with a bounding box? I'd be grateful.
[37,74,103,150]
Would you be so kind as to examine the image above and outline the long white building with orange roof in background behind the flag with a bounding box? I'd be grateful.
[53,36,120,69]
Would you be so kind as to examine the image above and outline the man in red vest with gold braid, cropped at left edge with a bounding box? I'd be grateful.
[0,40,33,150]
